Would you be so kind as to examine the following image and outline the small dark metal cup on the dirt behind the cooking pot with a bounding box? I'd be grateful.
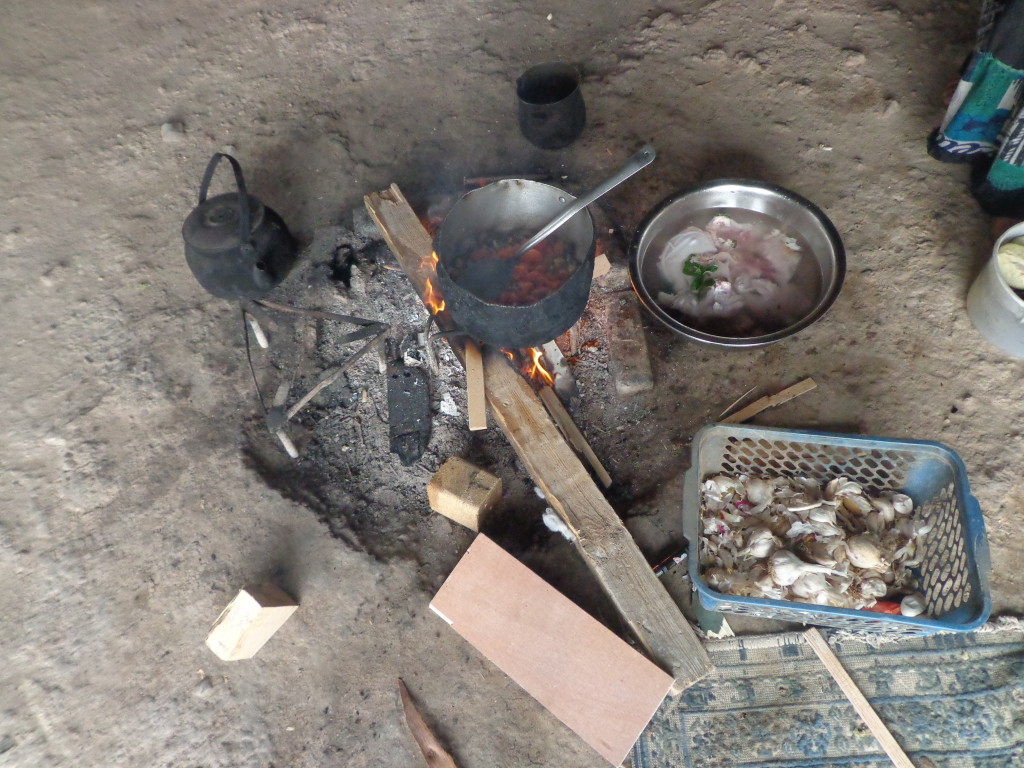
[515,61,587,150]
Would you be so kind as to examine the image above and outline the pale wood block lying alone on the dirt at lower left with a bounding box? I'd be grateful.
[206,584,299,662]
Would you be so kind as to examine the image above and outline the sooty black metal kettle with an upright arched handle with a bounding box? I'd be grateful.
[181,153,297,299]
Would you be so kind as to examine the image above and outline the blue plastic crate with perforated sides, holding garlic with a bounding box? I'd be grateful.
[683,424,992,635]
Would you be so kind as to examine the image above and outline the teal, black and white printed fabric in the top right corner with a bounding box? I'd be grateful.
[928,0,1024,219]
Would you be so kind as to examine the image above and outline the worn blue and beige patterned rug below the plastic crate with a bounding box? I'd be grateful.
[633,618,1024,768]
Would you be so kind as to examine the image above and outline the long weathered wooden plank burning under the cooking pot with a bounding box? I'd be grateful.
[365,184,711,692]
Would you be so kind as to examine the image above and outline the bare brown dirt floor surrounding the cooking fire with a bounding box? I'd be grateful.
[0,0,1024,768]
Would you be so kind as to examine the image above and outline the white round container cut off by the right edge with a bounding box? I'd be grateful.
[967,223,1024,359]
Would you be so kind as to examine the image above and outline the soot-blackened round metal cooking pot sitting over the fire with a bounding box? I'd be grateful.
[434,179,595,349]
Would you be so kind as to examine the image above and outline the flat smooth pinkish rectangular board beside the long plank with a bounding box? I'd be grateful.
[430,536,672,766]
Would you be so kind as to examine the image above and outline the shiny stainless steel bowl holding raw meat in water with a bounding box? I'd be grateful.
[630,179,846,347]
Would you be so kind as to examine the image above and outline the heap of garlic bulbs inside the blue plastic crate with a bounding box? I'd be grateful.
[699,474,934,610]
